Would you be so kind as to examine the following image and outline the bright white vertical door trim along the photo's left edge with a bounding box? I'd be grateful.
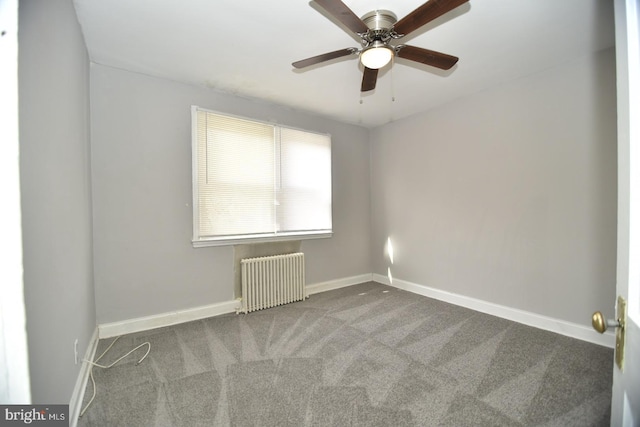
[0,0,31,404]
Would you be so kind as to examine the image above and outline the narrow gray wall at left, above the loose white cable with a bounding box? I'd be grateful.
[18,0,96,403]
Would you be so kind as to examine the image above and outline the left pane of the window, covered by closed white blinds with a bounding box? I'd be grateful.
[199,112,275,236]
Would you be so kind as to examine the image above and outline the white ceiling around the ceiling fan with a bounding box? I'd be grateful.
[74,0,614,127]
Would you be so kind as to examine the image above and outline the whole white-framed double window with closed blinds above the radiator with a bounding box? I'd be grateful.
[191,106,332,247]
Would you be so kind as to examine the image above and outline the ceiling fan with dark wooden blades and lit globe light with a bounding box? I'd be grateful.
[291,0,469,92]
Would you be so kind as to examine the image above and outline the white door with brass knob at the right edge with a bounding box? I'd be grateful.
[611,0,640,427]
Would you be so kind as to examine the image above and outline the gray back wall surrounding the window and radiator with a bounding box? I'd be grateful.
[91,64,371,323]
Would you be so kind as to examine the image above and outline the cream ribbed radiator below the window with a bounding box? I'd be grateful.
[238,252,307,313]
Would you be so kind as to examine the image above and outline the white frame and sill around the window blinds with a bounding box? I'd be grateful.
[191,105,333,248]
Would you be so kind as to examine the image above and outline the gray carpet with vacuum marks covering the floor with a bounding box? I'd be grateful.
[78,283,613,427]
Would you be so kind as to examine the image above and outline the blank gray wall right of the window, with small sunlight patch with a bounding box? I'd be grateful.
[371,49,616,325]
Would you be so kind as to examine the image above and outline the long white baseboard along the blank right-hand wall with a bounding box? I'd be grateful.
[373,273,615,348]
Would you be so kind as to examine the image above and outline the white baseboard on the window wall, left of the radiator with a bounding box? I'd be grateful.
[98,300,240,338]
